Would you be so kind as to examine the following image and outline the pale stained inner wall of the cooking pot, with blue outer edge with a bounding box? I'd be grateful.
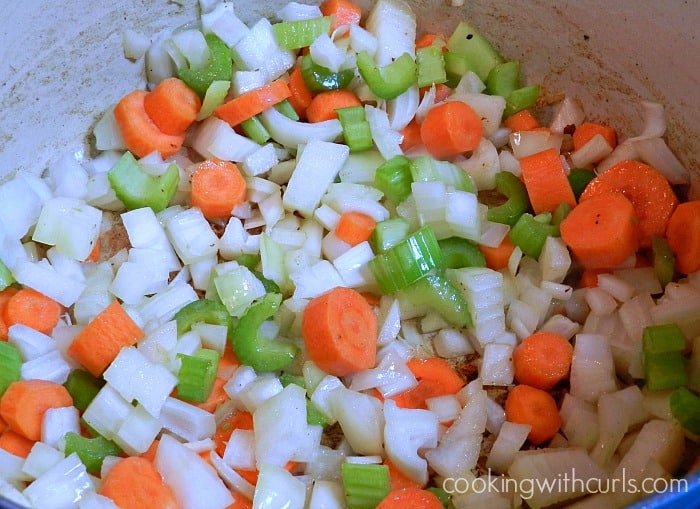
[0,0,700,507]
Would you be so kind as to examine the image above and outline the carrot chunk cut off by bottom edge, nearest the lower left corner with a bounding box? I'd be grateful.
[100,456,180,509]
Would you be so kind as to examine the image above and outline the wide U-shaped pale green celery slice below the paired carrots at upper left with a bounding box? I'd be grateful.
[107,151,180,212]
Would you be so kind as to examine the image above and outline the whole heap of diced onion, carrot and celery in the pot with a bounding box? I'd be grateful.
[0,0,700,509]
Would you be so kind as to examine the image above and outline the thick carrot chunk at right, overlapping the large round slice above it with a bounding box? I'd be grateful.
[559,193,638,269]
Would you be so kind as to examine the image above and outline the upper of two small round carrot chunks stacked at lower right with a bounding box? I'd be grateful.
[513,331,574,391]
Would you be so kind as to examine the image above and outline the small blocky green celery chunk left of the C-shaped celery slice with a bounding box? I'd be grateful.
[177,348,220,403]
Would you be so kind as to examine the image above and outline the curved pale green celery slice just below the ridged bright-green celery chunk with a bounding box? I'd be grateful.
[401,274,472,329]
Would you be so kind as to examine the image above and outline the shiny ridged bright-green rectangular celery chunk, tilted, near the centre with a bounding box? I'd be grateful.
[368,225,442,293]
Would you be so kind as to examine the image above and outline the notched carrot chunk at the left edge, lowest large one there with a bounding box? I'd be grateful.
[0,380,73,442]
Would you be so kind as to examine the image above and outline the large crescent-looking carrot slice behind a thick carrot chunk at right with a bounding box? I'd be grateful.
[579,160,678,248]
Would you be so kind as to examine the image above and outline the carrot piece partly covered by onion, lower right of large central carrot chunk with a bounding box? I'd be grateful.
[391,357,464,408]
